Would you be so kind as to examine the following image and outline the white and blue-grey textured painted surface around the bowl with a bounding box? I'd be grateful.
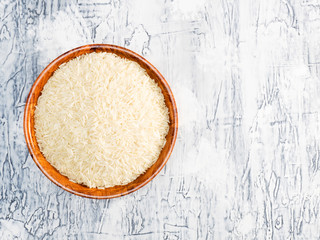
[0,0,320,239]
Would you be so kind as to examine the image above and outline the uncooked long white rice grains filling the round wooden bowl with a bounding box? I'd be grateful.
[35,53,169,188]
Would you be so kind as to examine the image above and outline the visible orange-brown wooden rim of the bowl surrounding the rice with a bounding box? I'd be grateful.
[23,44,178,199]
